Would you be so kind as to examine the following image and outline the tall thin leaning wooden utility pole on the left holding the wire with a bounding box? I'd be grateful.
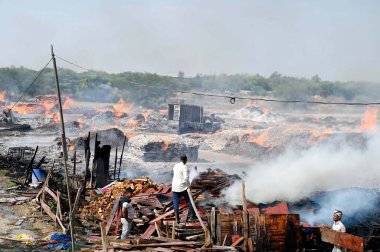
[51,45,75,251]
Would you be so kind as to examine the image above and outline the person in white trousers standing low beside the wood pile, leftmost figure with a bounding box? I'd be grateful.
[120,188,135,240]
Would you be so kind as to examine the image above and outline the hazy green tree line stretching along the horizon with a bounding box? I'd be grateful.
[0,67,380,107]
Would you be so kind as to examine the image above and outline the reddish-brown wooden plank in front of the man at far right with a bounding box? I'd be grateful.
[320,227,364,252]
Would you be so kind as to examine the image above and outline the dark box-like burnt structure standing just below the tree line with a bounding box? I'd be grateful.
[168,104,221,134]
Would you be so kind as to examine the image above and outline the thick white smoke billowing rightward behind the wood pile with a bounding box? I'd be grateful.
[225,134,380,204]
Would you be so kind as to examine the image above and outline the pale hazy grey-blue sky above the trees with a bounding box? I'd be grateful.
[0,0,380,81]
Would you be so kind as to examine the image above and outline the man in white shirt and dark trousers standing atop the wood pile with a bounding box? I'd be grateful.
[172,155,195,224]
